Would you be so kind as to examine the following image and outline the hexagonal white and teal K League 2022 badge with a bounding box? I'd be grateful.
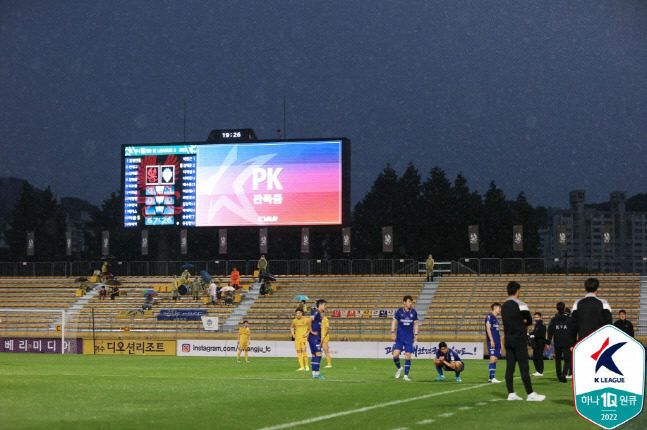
[573,325,645,429]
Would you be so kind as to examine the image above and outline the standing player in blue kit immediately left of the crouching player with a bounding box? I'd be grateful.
[391,296,418,381]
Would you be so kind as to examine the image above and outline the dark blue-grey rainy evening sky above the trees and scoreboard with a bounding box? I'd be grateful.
[0,0,647,207]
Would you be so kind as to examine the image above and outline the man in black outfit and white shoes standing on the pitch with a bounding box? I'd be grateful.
[501,281,546,402]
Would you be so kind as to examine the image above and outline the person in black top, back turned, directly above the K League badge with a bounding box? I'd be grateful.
[571,278,613,345]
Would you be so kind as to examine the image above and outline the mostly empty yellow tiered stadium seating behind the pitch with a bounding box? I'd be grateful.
[0,274,647,338]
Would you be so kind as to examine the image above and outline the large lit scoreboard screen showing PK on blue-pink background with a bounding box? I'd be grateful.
[122,138,350,228]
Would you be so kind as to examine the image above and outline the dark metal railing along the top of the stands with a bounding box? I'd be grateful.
[0,257,647,277]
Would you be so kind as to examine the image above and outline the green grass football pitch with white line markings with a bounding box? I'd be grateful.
[0,353,647,430]
